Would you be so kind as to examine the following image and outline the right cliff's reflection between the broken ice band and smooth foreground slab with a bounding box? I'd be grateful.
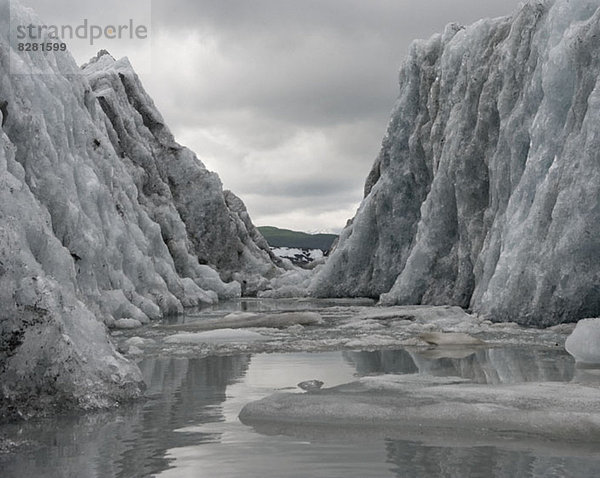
[344,347,575,384]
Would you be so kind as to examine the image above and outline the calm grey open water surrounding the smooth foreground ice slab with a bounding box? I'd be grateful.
[0,348,598,478]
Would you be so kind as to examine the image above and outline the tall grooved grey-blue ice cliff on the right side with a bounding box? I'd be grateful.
[311,0,600,326]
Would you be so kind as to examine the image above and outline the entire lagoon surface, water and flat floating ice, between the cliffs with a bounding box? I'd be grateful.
[0,299,600,478]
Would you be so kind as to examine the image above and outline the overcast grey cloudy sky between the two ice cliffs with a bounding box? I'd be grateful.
[22,0,521,231]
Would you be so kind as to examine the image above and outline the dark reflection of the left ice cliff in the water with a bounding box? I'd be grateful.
[0,355,250,478]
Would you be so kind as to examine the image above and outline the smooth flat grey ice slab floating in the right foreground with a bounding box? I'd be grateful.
[240,375,600,443]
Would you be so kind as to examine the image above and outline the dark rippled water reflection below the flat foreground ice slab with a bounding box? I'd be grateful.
[241,423,600,478]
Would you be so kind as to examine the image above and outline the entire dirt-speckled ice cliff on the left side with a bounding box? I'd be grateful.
[0,0,282,417]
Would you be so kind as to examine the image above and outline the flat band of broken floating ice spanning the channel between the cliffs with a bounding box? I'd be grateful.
[113,298,574,356]
